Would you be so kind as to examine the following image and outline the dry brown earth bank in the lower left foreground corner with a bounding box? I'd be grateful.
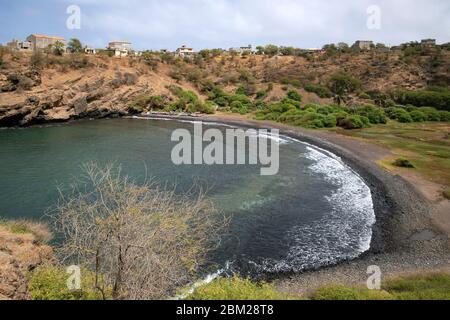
[0,222,53,300]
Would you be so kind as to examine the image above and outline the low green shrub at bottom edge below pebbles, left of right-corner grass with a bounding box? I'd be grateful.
[311,285,394,300]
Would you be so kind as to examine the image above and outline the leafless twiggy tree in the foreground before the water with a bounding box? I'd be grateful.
[51,164,228,299]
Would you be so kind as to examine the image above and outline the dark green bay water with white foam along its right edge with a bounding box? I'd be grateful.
[0,119,375,273]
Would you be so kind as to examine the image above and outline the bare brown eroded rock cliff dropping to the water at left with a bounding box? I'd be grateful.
[0,53,192,127]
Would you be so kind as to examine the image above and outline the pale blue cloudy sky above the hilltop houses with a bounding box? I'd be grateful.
[0,0,450,50]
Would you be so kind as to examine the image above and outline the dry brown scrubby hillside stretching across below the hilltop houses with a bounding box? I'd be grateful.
[0,48,450,127]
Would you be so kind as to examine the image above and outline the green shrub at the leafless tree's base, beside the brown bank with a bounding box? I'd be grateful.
[29,266,111,300]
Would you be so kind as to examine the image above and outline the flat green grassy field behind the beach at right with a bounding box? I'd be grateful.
[329,121,450,187]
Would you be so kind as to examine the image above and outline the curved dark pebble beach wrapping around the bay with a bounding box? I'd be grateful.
[132,115,450,292]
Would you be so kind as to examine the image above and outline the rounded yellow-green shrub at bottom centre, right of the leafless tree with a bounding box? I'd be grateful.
[188,277,289,300]
